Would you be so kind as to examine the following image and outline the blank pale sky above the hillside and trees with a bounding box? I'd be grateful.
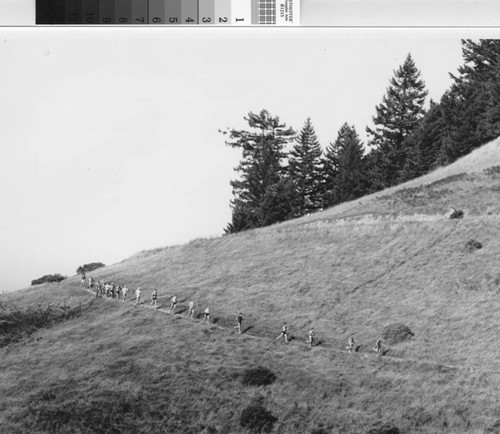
[0,28,498,291]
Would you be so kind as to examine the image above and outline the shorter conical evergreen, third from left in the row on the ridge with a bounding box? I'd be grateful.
[323,122,367,206]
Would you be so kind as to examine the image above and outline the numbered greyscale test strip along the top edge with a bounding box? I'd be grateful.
[36,0,300,26]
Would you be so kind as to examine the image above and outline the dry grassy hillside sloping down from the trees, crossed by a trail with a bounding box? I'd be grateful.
[0,137,500,433]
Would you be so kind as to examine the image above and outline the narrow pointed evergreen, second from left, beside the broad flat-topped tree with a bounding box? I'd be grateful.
[288,118,322,217]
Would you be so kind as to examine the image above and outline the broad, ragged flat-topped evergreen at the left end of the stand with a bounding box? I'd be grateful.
[223,110,295,233]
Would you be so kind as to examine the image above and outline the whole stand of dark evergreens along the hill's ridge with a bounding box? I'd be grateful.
[223,39,500,233]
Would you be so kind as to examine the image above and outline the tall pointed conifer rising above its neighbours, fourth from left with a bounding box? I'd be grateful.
[366,54,427,189]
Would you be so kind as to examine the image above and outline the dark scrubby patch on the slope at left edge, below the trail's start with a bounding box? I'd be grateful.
[0,304,82,348]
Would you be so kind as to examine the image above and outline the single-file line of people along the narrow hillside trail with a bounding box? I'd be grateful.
[80,274,382,355]
